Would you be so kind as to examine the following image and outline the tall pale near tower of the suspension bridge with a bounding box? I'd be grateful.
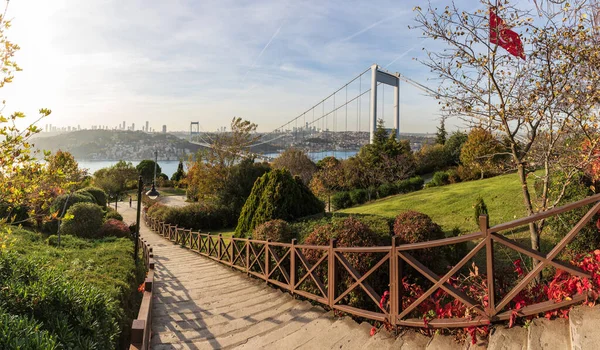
[369,64,400,143]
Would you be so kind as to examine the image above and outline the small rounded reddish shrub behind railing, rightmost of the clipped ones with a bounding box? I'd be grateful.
[394,210,446,272]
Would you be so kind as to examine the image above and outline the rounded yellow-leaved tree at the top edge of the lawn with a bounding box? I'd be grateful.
[460,127,503,179]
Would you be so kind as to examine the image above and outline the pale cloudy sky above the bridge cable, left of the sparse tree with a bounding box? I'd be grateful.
[2,0,478,133]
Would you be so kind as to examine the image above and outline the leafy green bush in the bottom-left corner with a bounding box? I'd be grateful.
[0,309,58,350]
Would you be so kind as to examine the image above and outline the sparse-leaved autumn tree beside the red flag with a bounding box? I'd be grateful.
[415,0,600,250]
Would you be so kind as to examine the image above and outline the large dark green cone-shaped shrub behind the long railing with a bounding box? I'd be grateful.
[235,169,325,237]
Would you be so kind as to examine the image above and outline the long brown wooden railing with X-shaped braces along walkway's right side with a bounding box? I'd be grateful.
[144,195,600,328]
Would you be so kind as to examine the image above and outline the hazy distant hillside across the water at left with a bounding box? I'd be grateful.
[33,130,206,160]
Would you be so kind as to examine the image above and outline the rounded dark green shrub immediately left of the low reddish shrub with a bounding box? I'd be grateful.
[61,203,104,238]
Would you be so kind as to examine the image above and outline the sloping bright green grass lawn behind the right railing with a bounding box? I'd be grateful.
[339,174,526,233]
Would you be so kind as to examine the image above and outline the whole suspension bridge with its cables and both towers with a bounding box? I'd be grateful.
[189,64,435,161]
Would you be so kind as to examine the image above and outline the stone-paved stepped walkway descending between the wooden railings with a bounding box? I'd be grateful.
[119,201,600,350]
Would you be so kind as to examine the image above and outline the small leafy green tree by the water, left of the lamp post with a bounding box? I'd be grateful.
[94,160,139,209]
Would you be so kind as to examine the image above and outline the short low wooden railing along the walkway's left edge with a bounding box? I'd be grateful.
[129,237,154,350]
